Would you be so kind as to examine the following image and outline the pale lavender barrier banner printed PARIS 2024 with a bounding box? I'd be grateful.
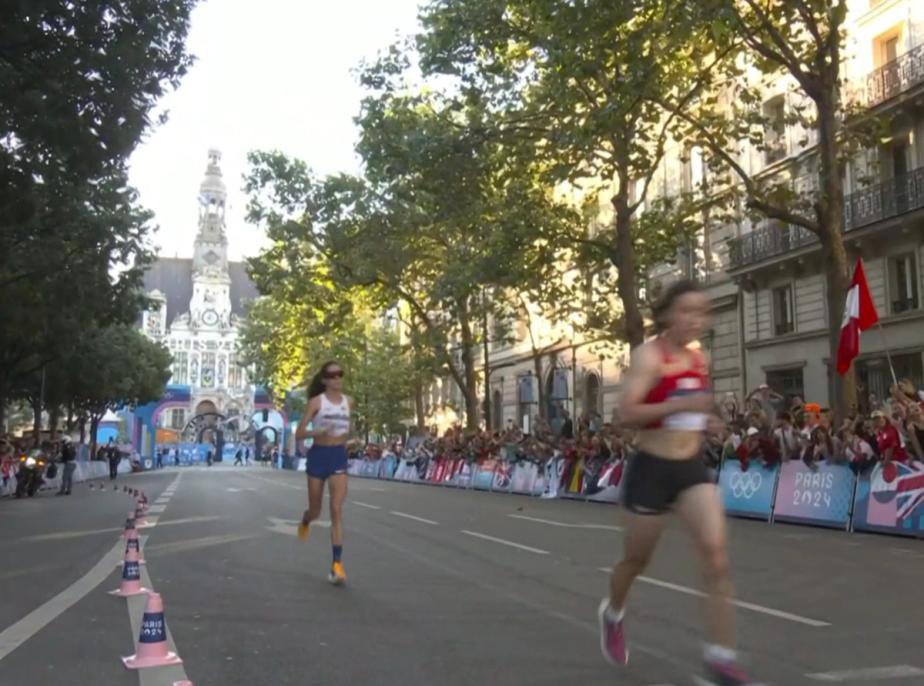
[773,460,856,529]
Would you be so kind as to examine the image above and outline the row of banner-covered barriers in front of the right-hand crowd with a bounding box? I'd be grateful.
[338,455,924,538]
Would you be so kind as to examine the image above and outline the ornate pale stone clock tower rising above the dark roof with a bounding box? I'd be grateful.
[189,150,231,330]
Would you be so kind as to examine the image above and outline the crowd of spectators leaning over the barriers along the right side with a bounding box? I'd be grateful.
[365,379,924,482]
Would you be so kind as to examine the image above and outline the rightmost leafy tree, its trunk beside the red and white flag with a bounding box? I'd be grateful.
[677,0,879,412]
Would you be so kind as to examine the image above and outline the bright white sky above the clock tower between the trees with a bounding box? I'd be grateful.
[131,0,419,259]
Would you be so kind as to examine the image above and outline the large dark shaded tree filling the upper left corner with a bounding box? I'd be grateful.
[0,0,195,423]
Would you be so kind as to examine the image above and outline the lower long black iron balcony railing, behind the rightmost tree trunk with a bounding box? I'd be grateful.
[728,167,924,269]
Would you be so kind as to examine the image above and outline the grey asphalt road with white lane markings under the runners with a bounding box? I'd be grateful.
[0,466,924,686]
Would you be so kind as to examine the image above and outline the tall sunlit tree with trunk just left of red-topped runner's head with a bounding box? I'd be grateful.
[418,0,720,346]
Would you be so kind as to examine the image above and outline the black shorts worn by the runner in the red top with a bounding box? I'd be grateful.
[623,452,713,515]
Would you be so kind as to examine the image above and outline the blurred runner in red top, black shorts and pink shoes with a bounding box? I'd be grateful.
[599,281,752,686]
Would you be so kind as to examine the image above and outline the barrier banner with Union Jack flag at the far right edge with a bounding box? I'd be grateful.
[853,462,924,538]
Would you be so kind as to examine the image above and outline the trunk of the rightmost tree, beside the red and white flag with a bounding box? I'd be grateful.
[816,83,857,417]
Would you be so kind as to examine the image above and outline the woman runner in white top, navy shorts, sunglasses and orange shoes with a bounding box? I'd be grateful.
[295,362,350,586]
